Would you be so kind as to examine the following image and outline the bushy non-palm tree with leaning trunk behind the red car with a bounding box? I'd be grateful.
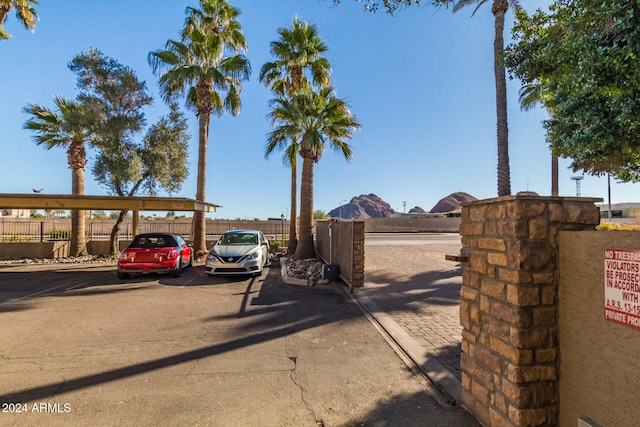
[69,49,188,253]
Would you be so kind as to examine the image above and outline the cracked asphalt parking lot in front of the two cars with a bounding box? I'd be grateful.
[0,264,477,426]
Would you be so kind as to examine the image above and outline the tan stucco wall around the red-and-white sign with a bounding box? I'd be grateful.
[558,231,640,427]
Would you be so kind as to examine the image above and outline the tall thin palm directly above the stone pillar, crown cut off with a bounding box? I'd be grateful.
[450,0,520,196]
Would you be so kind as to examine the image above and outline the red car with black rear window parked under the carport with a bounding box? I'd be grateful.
[118,233,193,279]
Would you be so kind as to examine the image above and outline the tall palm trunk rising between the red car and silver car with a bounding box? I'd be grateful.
[193,112,211,258]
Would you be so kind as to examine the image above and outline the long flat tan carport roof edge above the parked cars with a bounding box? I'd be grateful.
[0,193,222,212]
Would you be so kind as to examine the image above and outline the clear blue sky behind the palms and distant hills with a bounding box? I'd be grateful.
[0,0,637,219]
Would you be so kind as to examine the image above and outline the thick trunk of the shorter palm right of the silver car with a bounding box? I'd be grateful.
[295,155,316,259]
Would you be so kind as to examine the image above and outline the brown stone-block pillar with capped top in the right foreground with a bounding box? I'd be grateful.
[460,196,601,426]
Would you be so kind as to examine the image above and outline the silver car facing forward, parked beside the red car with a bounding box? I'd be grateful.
[205,230,269,275]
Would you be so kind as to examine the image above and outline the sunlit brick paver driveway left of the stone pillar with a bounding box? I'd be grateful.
[355,242,462,381]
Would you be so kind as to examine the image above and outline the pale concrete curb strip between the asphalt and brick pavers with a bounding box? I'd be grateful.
[351,292,462,405]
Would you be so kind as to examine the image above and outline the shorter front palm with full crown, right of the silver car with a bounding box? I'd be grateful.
[270,87,360,258]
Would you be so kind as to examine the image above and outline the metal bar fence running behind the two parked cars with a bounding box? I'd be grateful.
[0,218,289,242]
